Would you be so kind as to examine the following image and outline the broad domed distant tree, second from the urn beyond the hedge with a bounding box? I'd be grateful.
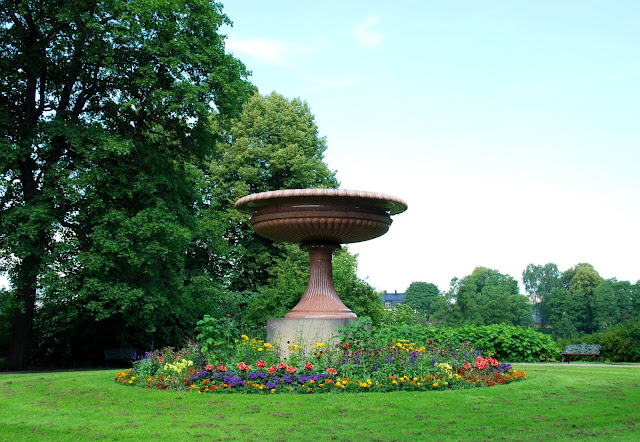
[438,267,532,326]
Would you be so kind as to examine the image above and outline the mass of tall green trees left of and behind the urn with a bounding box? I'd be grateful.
[0,0,381,369]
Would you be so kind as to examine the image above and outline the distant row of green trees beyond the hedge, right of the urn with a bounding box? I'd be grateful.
[395,263,640,338]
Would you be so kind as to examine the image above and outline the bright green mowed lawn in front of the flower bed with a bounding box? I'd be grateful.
[0,364,640,441]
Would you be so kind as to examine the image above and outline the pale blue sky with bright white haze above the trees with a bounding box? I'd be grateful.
[222,0,640,292]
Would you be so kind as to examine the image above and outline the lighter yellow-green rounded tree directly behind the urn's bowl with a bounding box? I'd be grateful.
[209,92,339,291]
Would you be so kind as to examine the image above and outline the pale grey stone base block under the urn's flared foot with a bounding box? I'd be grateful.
[267,318,353,358]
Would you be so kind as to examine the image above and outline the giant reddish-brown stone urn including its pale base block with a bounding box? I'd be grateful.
[235,189,407,354]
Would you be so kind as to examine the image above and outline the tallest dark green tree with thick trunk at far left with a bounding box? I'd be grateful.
[0,0,253,368]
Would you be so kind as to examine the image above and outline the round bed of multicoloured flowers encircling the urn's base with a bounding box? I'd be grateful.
[114,335,526,394]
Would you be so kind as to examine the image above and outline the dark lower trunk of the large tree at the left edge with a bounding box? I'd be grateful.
[7,255,38,370]
